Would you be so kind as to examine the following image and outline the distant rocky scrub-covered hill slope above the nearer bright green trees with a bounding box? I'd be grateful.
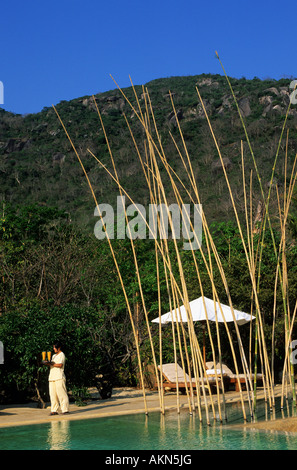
[0,75,297,231]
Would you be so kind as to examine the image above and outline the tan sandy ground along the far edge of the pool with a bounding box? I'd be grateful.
[0,386,297,432]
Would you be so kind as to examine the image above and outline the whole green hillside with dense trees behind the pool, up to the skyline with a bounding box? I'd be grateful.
[0,75,297,403]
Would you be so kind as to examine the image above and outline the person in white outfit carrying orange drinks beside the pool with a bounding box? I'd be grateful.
[48,342,69,415]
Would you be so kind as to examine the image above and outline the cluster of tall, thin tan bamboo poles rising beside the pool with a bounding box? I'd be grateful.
[54,55,297,424]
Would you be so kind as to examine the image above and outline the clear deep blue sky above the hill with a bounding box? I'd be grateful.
[0,0,297,114]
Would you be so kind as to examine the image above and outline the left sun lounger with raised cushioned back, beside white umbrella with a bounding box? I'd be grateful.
[158,363,221,392]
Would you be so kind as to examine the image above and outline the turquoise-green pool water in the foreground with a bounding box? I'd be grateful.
[0,403,297,450]
